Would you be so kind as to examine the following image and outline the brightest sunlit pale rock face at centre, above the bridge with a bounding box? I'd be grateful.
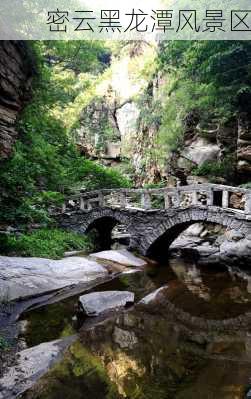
[76,42,156,163]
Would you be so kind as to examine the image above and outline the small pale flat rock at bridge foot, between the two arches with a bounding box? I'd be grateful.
[90,249,146,267]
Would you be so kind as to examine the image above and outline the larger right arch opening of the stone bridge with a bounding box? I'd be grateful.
[146,221,226,263]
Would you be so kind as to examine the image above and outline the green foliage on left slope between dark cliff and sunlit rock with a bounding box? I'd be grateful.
[0,41,127,228]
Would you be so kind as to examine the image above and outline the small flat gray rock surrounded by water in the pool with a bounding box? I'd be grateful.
[79,291,134,316]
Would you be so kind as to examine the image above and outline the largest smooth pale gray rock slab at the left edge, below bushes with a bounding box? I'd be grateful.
[0,256,108,301]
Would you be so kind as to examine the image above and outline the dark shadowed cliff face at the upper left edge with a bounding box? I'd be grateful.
[0,41,34,159]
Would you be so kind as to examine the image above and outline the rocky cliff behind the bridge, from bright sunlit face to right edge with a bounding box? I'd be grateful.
[73,43,251,186]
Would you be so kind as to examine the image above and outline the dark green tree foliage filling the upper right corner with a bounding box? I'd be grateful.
[160,41,251,121]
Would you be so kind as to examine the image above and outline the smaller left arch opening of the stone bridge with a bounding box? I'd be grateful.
[86,216,129,251]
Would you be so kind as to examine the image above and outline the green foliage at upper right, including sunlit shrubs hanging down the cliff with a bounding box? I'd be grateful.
[158,41,251,166]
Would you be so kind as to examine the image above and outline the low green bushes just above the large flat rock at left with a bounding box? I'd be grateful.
[1,229,93,259]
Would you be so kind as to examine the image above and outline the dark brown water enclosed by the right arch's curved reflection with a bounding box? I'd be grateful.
[164,259,251,320]
